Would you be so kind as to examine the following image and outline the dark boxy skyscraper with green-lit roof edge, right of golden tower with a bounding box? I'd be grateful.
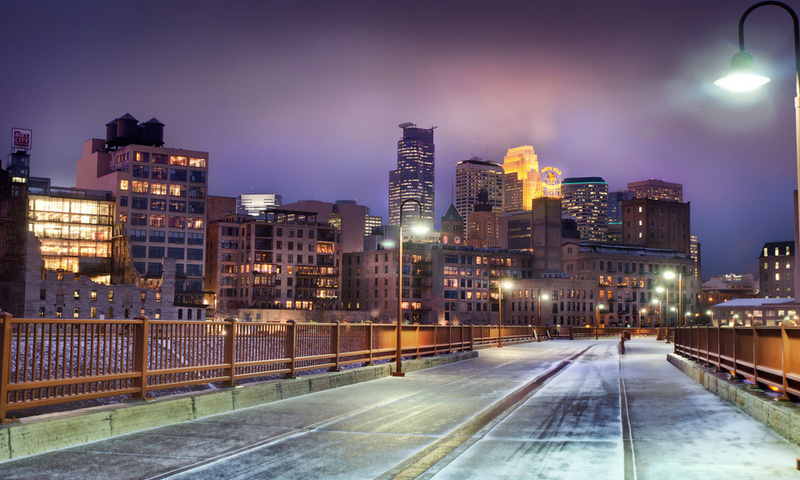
[561,177,608,242]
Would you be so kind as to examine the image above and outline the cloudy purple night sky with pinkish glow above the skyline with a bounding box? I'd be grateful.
[0,0,796,278]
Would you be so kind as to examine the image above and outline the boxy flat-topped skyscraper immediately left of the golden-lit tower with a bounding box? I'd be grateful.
[455,157,503,238]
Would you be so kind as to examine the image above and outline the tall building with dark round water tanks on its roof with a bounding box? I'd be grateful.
[77,114,208,309]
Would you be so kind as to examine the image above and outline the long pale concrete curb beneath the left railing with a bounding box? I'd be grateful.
[0,351,478,462]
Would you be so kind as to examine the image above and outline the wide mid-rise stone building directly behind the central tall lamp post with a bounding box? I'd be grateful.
[342,242,533,325]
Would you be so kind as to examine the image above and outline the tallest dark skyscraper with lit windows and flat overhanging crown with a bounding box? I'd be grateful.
[389,123,436,228]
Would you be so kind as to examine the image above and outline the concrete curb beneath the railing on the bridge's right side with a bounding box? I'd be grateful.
[667,353,800,445]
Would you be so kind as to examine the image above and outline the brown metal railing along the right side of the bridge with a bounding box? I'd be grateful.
[672,326,800,398]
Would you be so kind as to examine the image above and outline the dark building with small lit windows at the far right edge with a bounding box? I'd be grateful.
[758,241,795,298]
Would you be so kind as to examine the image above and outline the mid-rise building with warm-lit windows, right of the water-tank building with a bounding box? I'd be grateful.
[206,209,341,318]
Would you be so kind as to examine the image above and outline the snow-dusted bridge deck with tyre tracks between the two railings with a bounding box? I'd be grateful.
[0,338,800,480]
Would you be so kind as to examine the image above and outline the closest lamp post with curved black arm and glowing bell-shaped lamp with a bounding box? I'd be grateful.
[714,1,800,296]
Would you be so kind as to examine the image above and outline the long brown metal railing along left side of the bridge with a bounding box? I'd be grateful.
[0,314,545,422]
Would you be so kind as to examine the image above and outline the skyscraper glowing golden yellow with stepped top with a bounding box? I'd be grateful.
[503,145,542,212]
